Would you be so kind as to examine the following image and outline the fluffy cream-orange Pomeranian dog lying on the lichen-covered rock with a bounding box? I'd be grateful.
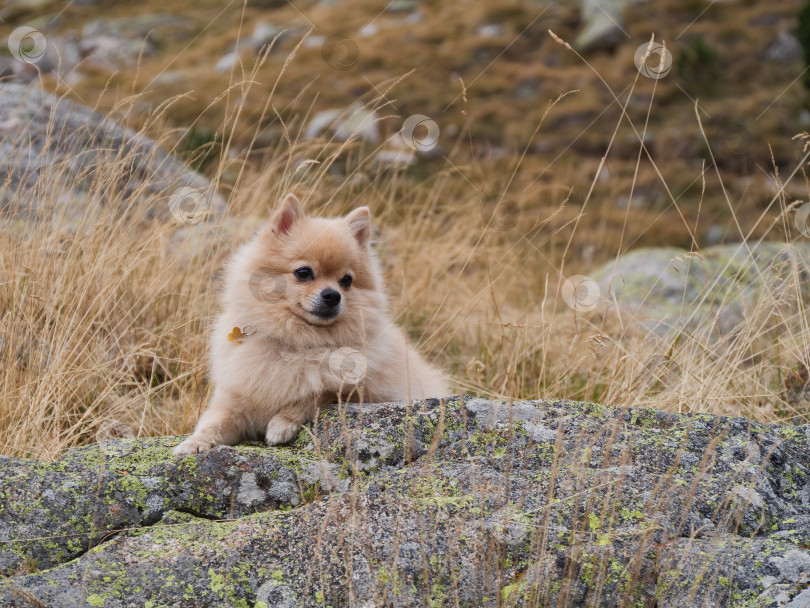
[174,194,449,455]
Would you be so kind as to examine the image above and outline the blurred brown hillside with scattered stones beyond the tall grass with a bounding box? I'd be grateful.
[2,0,810,252]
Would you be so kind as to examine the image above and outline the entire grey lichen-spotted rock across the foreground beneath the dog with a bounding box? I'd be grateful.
[0,397,810,608]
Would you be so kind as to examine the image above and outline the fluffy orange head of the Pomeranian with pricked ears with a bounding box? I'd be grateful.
[249,194,378,326]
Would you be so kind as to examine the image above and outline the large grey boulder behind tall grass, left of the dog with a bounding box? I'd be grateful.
[0,83,224,232]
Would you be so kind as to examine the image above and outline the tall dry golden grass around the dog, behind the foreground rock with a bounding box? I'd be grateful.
[0,84,810,458]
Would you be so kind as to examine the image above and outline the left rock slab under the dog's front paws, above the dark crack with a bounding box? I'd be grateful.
[0,438,328,574]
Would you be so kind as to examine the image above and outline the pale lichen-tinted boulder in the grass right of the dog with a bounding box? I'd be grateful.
[591,243,810,334]
